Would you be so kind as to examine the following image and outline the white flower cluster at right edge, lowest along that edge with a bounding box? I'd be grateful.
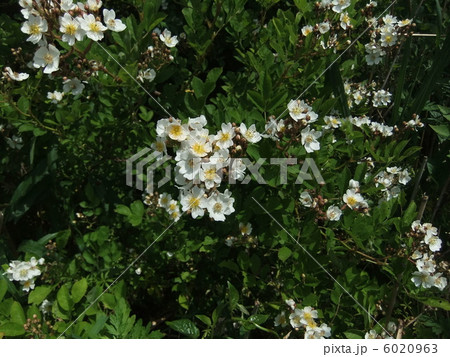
[410,221,447,291]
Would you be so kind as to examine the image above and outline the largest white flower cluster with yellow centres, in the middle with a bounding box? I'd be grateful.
[148,115,262,221]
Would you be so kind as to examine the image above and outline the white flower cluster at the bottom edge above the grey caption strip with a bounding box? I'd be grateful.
[274,299,331,339]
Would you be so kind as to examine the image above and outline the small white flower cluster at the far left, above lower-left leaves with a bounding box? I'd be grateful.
[3,257,44,292]
